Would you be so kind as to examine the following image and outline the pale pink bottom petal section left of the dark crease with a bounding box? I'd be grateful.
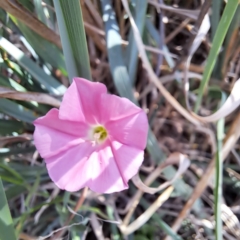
[88,142,128,193]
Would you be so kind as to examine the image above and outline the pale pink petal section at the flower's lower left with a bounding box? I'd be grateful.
[46,142,95,192]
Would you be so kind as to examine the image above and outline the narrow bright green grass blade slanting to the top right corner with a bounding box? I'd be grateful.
[194,0,239,112]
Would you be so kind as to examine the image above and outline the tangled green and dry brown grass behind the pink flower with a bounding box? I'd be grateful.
[0,0,240,240]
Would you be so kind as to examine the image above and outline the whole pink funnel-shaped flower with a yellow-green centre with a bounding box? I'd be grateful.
[34,78,148,193]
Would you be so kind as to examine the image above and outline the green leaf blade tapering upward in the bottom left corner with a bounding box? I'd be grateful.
[0,178,16,240]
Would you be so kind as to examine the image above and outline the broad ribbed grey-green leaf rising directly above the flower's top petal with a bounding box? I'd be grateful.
[54,0,91,81]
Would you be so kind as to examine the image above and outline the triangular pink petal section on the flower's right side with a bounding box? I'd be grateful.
[105,111,148,149]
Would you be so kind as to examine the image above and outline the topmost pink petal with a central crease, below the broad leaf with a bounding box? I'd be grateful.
[59,78,107,124]
